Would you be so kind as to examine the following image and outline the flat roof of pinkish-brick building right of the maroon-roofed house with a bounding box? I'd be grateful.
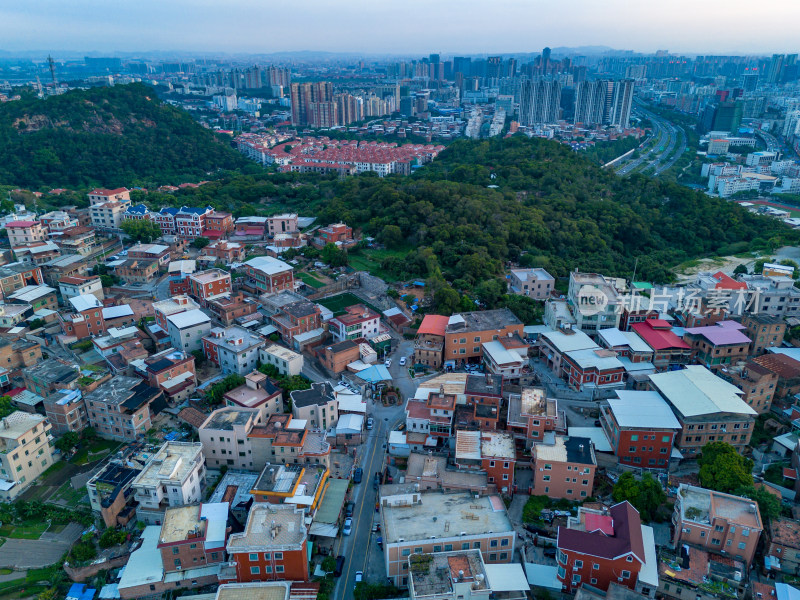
[678,483,763,529]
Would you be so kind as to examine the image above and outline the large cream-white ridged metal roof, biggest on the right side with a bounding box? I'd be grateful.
[648,365,757,417]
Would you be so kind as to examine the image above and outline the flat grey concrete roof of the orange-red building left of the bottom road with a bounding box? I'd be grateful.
[227,503,306,553]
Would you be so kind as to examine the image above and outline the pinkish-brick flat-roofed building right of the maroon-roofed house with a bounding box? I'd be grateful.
[672,483,764,568]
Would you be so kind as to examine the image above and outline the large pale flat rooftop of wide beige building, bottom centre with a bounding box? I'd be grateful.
[382,493,514,544]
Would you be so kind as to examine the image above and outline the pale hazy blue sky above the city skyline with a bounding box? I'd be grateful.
[0,0,800,55]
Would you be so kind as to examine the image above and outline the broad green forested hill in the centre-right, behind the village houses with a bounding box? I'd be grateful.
[310,136,798,289]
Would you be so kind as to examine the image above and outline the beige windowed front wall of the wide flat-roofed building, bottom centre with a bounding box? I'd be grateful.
[384,531,516,587]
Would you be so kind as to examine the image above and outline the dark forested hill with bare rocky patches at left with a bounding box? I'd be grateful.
[0,83,247,189]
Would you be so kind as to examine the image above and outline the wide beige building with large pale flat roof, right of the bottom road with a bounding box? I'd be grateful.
[380,488,516,587]
